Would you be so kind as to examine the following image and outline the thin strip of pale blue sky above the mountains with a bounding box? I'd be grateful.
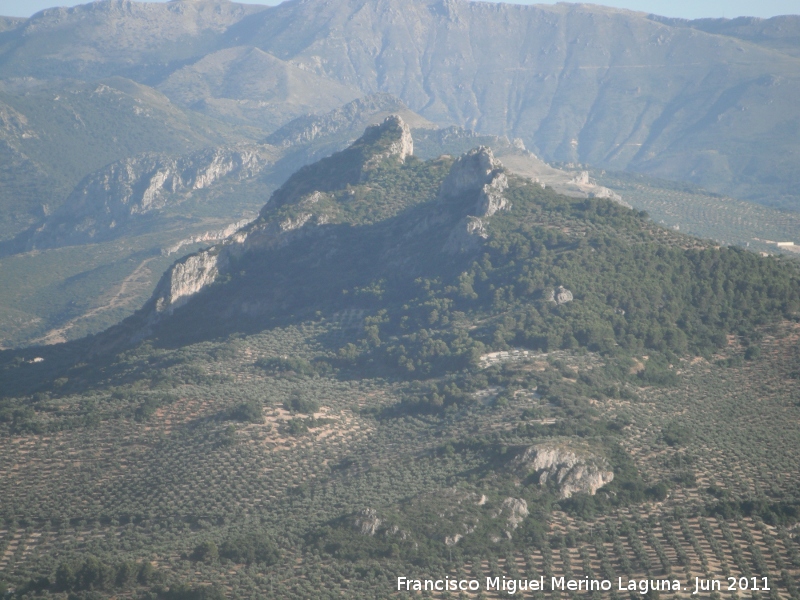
[0,0,800,19]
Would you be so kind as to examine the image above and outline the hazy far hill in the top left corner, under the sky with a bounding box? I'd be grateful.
[0,0,264,83]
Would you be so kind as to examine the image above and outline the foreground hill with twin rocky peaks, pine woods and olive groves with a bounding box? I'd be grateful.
[0,117,800,599]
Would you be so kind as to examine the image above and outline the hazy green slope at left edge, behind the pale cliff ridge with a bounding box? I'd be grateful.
[0,77,263,239]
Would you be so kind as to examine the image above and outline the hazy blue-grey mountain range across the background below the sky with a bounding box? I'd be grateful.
[0,0,800,221]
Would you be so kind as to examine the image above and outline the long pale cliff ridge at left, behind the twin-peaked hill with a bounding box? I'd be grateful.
[19,145,274,249]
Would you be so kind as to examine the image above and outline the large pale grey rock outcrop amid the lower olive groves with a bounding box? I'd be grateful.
[514,444,614,498]
